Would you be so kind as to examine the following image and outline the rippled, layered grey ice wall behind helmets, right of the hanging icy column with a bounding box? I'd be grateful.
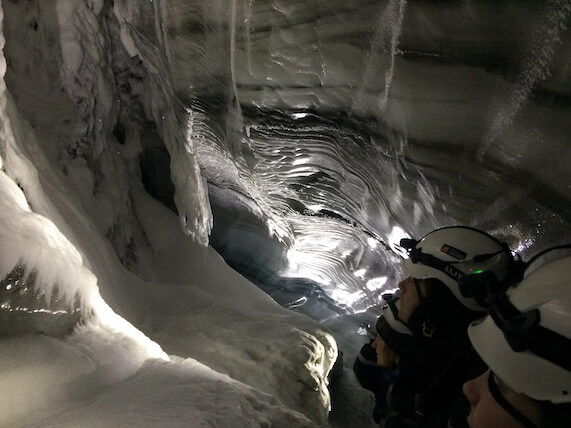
[155,0,571,311]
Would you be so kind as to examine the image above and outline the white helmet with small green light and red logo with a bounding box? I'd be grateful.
[400,226,519,311]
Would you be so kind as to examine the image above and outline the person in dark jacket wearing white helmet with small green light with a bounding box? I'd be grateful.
[384,226,518,428]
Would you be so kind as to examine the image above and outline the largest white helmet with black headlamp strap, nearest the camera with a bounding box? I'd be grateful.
[468,256,571,404]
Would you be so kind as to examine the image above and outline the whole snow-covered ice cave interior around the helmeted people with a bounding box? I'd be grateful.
[0,0,571,428]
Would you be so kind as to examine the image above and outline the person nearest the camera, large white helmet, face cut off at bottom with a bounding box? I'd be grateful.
[463,256,571,428]
